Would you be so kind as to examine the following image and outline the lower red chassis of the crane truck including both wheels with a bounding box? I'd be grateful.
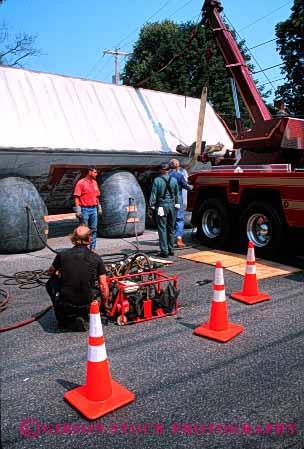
[188,165,304,256]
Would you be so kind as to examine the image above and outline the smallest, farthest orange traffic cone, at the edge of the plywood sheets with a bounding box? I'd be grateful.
[230,242,271,304]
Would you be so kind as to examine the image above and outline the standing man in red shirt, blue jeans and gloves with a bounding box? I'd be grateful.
[74,166,102,249]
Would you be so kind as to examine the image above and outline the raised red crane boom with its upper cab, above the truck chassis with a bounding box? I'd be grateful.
[202,0,304,167]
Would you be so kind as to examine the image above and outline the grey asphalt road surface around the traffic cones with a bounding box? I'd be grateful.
[0,230,304,449]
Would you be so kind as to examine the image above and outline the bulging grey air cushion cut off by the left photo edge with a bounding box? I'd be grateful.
[0,176,48,254]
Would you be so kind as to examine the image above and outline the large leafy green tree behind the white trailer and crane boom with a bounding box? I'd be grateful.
[122,20,264,128]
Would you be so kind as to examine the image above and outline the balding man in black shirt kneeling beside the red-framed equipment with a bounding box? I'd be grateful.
[46,225,109,331]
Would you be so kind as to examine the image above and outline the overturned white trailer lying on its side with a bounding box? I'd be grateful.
[0,66,232,251]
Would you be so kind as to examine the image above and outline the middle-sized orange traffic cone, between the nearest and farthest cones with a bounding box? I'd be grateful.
[193,262,244,343]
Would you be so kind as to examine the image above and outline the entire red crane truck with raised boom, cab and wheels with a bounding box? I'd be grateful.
[188,0,304,256]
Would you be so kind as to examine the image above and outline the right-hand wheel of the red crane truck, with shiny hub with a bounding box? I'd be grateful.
[241,201,284,257]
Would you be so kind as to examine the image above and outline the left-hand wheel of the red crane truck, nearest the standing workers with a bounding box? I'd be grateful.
[197,198,231,248]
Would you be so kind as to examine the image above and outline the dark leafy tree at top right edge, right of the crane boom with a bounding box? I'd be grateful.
[276,0,304,116]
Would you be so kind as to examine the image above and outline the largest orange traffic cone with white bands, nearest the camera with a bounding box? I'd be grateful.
[64,301,135,420]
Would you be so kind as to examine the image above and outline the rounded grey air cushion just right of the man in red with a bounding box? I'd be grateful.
[98,170,146,238]
